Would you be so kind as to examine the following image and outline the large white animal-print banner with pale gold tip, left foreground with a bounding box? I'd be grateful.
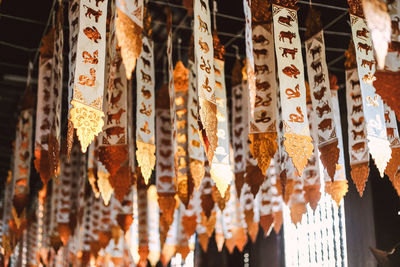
[70,0,108,152]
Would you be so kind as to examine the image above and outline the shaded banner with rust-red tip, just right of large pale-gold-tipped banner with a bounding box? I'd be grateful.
[98,30,132,201]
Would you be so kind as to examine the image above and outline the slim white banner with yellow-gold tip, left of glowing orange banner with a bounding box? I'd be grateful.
[136,9,156,184]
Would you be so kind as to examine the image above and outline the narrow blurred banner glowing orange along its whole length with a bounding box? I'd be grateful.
[173,60,194,207]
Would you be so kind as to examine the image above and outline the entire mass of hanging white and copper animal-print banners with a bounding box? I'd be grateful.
[1,0,400,266]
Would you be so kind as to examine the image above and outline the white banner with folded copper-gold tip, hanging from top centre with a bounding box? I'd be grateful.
[194,0,218,162]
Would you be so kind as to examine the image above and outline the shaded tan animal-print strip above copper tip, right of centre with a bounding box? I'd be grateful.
[247,11,277,133]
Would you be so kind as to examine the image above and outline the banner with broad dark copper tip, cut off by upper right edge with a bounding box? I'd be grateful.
[374,0,400,117]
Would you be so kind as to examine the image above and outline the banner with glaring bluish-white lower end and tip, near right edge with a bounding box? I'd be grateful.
[350,15,392,177]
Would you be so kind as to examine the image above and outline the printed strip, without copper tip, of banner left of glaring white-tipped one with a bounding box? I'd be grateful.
[346,69,369,165]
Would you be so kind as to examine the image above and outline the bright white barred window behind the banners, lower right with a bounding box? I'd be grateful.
[283,176,347,267]
